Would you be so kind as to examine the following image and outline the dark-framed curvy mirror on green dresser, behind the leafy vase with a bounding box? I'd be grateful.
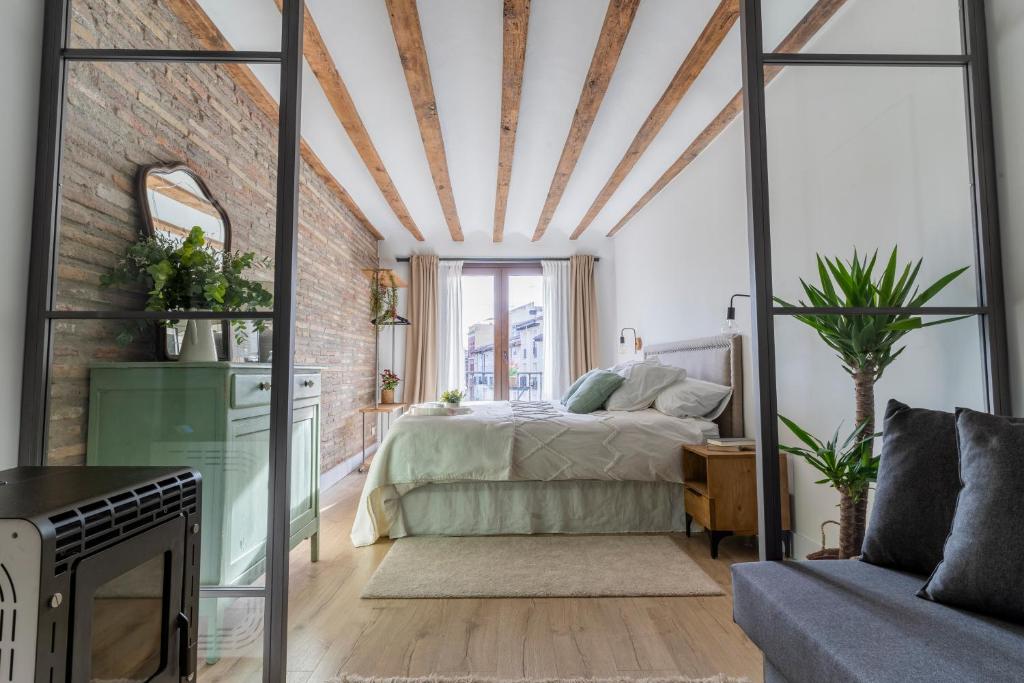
[137,164,231,360]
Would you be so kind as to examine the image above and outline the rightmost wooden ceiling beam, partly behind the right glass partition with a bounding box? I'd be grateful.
[607,0,846,238]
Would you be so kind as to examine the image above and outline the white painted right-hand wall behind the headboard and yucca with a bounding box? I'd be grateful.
[615,0,1024,554]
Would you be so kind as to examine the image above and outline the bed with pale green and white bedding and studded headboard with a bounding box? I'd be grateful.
[351,335,743,546]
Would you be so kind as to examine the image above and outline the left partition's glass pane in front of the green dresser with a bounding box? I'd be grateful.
[47,321,276,586]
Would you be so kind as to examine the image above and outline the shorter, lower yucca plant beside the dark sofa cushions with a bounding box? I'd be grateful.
[778,415,879,558]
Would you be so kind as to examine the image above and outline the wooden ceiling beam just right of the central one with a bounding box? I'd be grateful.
[534,0,640,242]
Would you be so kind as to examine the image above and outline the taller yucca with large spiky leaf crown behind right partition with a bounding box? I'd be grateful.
[775,247,968,557]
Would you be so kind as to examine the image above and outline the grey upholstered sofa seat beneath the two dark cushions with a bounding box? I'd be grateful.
[732,560,1024,683]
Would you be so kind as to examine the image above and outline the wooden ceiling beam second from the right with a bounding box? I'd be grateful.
[570,0,739,240]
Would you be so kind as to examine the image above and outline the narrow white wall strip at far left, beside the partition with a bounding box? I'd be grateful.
[0,0,43,469]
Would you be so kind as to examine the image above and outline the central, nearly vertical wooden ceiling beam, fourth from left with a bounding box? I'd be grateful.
[494,0,530,242]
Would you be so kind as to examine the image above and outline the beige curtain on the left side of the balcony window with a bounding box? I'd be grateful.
[403,255,437,403]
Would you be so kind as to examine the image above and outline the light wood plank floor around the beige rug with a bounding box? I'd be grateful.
[199,473,762,683]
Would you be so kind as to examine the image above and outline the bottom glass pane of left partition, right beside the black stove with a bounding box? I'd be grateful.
[198,598,263,682]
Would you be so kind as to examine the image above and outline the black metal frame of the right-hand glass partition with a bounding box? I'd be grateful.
[740,0,1011,560]
